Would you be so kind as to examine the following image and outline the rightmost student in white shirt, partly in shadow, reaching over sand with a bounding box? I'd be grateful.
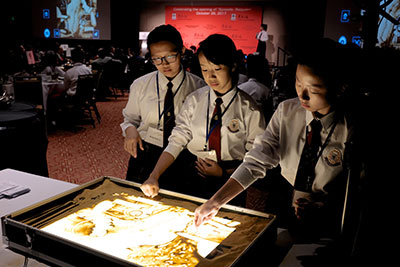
[195,39,351,241]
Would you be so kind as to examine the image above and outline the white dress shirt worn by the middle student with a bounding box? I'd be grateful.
[164,86,265,161]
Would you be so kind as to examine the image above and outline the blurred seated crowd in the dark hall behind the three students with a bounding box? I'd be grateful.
[0,42,288,117]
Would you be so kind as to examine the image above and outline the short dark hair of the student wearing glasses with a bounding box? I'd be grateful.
[147,24,183,52]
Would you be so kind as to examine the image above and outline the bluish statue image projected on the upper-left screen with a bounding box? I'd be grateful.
[57,0,97,39]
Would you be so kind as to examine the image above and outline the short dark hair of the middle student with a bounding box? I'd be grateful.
[197,34,239,85]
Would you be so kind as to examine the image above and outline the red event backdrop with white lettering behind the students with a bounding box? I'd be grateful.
[165,6,262,54]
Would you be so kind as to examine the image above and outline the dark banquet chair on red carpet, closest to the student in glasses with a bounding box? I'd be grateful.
[75,74,101,128]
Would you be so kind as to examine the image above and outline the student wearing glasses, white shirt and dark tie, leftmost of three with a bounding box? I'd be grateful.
[121,25,205,188]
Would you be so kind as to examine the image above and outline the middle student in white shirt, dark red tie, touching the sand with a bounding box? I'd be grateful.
[141,34,265,205]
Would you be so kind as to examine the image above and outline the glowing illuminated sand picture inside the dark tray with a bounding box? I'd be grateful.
[42,195,240,266]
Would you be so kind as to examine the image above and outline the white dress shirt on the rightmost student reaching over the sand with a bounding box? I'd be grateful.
[232,98,349,196]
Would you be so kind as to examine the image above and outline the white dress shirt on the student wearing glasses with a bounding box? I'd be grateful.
[121,70,206,139]
